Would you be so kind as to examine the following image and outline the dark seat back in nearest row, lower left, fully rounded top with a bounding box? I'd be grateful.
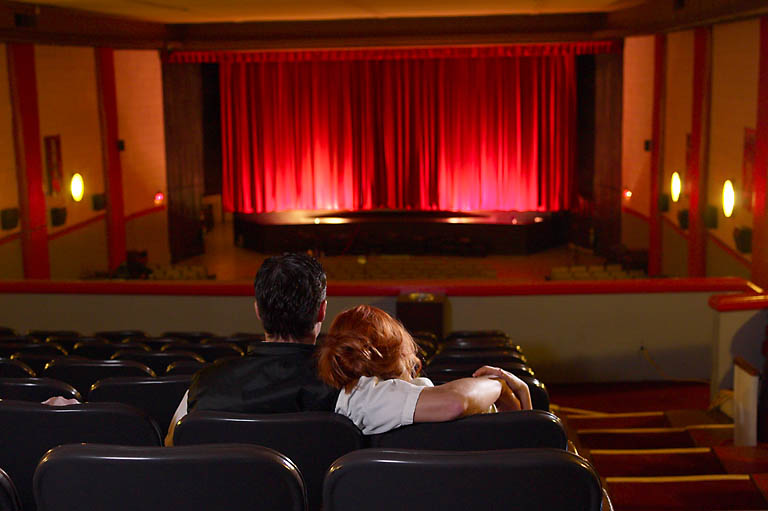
[34,444,306,511]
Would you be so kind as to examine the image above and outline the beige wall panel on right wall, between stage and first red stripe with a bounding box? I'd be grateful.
[621,36,654,224]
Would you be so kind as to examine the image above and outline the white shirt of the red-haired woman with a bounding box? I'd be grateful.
[336,376,434,435]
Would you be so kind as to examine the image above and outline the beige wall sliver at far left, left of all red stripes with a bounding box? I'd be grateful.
[0,44,21,260]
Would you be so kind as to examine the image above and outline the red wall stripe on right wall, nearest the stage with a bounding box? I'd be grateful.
[648,34,667,277]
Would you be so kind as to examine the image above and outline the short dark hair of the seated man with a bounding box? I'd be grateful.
[253,254,326,340]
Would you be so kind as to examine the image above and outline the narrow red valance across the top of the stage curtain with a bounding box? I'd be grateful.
[165,40,622,64]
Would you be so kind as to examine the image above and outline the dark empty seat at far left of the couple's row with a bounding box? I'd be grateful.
[0,400,160,511]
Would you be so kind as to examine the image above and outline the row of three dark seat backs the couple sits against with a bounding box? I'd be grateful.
[0,400,588,510]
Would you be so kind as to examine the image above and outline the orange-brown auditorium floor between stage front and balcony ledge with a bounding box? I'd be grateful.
[179,223,605,284]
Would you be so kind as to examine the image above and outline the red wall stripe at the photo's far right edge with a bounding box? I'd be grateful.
[752,16,768,287]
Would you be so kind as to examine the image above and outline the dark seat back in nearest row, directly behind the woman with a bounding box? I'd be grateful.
[323,449,602,511]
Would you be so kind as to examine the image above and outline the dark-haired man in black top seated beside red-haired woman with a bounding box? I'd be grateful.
[165,254,339,445]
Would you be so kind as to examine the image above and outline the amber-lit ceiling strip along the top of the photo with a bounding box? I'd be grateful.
[15,0,644,23]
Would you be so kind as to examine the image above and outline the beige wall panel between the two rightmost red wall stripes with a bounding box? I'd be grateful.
[707,20,760,266]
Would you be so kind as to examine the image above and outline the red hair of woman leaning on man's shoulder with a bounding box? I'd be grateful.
[318,305,421,391]
